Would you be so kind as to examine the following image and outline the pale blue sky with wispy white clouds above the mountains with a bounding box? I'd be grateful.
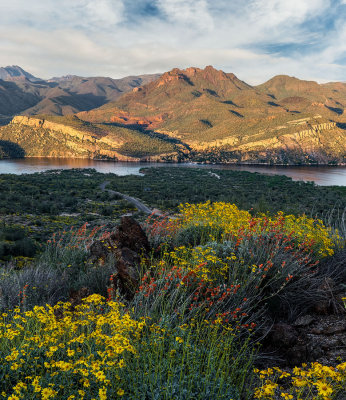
[0,0,346,84]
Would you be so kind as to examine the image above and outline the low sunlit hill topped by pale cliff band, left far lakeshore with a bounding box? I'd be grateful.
[0,116,178,161]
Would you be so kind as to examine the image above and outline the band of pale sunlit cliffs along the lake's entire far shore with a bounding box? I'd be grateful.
[0,115,346,164]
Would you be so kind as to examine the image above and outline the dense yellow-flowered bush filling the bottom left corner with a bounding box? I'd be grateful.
[0,294,145,399]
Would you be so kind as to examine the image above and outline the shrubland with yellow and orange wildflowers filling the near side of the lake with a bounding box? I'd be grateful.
[0,168,346,400]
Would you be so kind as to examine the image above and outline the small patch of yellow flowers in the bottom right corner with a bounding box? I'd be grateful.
[254,362,346,400]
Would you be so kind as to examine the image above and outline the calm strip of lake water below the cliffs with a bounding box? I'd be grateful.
[0,158,346,186]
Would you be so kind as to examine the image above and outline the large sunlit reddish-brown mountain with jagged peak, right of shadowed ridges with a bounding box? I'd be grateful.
[79,66,346,163]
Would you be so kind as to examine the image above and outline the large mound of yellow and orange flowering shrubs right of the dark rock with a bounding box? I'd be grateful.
[141,202,344,330]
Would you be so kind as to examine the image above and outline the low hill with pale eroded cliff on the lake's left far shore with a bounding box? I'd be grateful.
[0,116,175,162]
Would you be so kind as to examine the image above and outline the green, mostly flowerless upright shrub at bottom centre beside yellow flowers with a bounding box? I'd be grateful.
[119,319,253,400]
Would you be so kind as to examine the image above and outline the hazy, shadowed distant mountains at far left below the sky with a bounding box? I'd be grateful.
[0,66,160,122]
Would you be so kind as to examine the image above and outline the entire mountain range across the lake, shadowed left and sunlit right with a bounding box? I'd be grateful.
[0,66,346,165]
